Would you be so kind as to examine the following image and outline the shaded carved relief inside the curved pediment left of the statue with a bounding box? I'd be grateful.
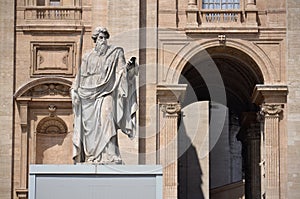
[23,83,70,97]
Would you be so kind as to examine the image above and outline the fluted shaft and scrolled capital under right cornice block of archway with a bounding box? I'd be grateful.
[261,104,282,199]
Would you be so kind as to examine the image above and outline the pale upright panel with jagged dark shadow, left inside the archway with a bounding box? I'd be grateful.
[178,102,209,199]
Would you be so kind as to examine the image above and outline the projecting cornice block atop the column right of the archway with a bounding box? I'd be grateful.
[252,84,288,105]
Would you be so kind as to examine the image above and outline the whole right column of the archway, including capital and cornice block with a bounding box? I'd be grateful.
[252,85,288,199]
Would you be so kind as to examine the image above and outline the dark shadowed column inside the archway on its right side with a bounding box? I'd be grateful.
[247,123,261,199]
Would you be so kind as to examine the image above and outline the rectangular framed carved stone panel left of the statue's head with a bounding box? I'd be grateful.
[31,42,76,77]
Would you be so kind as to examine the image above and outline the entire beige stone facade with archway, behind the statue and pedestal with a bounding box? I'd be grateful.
[0,0,300,199]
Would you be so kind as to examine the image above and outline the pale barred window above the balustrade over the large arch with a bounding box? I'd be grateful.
[202,0,240,10]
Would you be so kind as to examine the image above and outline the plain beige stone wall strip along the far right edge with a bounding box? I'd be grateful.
[287,0,300,199]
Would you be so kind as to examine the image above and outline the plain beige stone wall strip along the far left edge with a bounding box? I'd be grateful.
[0,0,15,199]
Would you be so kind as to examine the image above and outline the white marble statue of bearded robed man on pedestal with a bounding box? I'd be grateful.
[71,27,138,164]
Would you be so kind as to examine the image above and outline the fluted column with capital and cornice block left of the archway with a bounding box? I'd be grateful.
[157,85,186,199]
